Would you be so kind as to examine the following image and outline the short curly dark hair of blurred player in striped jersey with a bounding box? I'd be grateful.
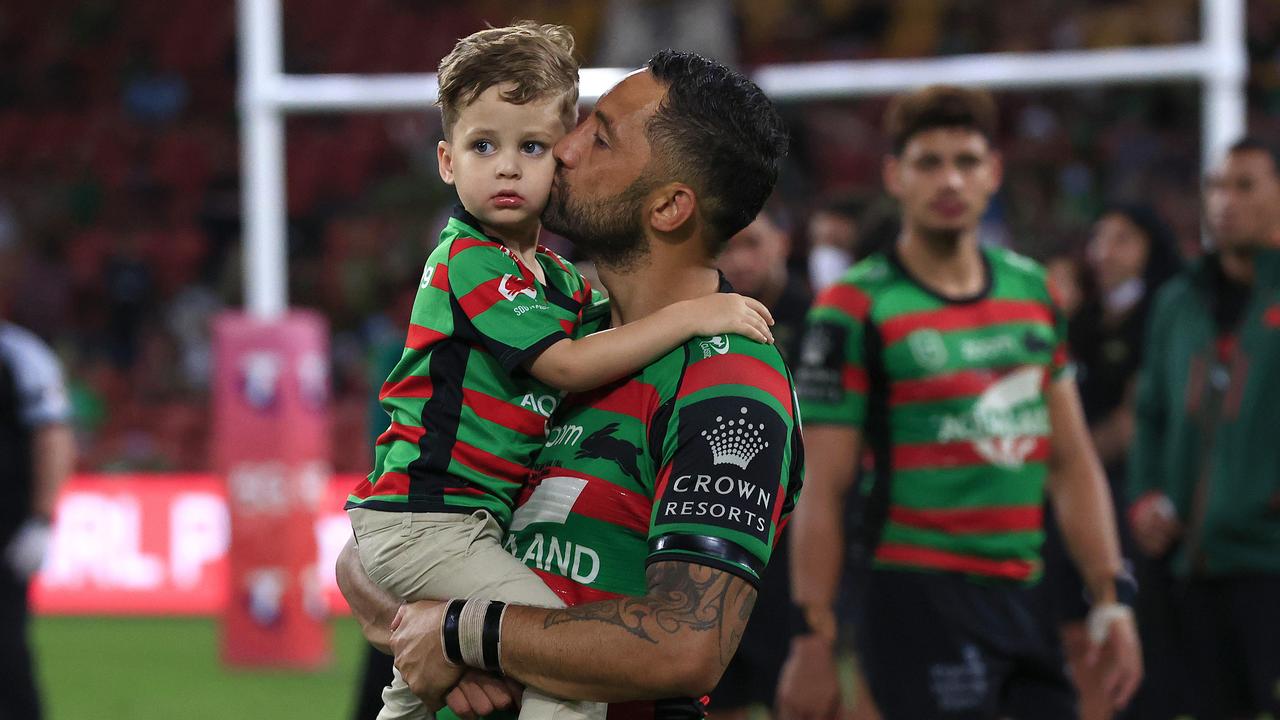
[884,85,998,155]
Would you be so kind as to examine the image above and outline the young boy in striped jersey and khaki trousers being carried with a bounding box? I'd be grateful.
[347,22,772,720]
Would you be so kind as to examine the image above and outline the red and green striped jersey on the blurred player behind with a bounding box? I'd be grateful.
[796,249,1068,582]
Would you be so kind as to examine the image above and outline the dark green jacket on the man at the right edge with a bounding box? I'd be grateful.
[1129,251,1280,577]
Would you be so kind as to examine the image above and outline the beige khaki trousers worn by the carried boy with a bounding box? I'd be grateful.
[347,507,605,720]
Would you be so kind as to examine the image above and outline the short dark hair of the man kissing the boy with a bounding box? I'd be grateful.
[648,50,787,245]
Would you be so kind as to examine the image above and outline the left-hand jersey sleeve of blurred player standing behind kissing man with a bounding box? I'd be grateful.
[796,283,870,428]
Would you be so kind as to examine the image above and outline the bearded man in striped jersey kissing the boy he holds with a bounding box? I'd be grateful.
[338,51,803,717]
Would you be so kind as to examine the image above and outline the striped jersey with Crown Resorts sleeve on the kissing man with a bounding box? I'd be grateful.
[507,316,804,605]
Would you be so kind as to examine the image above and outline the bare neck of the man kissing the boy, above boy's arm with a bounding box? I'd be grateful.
[596,248,719,324]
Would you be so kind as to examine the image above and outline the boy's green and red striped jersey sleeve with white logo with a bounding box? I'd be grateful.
[448,238,573,372]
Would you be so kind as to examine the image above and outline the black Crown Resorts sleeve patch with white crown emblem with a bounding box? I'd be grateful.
[654,397,788,542]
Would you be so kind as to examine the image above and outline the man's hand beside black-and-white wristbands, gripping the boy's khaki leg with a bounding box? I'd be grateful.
[390,600,466,712]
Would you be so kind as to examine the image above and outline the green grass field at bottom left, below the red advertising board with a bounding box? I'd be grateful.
[32,618,365,720]
